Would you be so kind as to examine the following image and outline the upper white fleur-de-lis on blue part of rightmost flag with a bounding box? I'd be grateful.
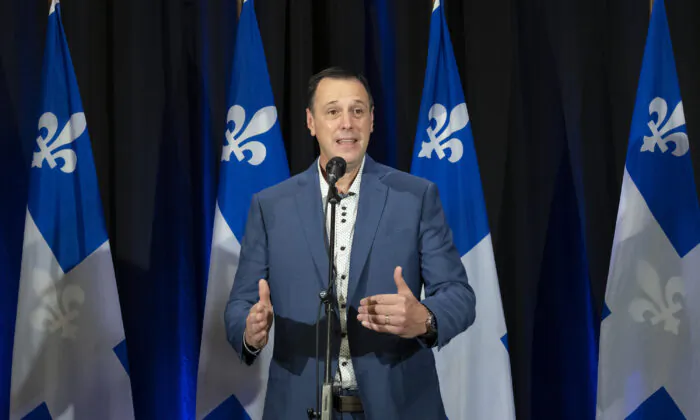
[640,98,689,156]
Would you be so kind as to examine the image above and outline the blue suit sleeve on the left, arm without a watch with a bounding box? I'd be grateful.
[224,195,268,365]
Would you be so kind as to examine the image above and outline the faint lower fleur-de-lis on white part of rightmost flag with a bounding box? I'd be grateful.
[629,261,685,335]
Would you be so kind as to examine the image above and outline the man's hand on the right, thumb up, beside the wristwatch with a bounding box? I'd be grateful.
[357,267,429,338]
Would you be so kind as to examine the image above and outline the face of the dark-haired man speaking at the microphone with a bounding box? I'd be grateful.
[306,78,374,171]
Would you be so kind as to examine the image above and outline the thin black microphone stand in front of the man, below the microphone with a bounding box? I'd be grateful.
[307,182,341,420]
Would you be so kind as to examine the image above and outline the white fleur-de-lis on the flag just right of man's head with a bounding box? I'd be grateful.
[418,102,469,163]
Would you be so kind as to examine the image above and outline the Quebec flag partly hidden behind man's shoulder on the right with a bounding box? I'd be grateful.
[411,0,515,420]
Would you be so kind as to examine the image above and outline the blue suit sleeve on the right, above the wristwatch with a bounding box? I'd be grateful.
[419,183,476,348]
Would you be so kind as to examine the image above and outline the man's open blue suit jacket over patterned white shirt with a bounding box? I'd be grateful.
[225,156,475,419]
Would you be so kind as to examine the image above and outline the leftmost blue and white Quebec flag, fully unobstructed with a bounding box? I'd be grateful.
[10,0,134,420]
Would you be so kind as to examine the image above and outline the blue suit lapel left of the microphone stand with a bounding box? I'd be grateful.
[296,161,328,289]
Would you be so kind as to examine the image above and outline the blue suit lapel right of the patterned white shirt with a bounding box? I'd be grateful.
[348,156,388,301]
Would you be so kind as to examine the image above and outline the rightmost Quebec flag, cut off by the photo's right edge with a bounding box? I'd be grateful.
[596,0,700,420]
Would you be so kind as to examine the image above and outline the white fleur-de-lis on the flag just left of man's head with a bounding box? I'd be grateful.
[221,105,277,165]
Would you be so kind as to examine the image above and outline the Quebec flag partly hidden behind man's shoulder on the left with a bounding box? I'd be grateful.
[197,0,289,420]
